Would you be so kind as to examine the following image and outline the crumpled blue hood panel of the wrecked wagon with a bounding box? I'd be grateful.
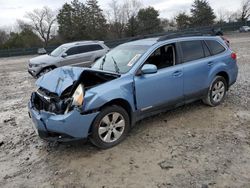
[36,66,87,96]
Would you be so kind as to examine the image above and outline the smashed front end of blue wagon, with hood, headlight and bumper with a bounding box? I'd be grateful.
[29,67,119,140]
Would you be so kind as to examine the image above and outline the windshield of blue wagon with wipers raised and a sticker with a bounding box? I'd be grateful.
[92,45,150,73]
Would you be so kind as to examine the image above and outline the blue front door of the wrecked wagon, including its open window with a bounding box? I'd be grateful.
[134,44,183,112]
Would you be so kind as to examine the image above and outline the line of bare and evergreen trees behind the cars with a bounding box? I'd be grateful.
[0,0,250,48]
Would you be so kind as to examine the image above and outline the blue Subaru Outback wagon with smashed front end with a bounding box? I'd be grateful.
[28,36,238,148]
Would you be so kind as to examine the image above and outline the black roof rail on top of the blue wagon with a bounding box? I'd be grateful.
[157,31,215,42]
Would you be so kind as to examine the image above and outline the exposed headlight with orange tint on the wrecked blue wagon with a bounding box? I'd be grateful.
[64,84,84,114]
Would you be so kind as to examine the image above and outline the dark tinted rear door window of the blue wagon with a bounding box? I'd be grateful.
[181,40,204,62]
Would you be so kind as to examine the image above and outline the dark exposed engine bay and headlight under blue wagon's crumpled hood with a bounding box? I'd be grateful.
[31,70,120,114]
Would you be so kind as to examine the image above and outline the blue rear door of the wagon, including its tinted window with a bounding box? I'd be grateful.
[179,40,214,100]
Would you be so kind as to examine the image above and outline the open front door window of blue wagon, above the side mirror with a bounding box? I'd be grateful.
[145,44,176,69]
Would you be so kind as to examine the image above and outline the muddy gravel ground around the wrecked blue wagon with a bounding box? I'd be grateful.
[0,34,250,188]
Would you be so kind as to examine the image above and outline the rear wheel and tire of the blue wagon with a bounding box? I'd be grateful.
[203,76,227,106]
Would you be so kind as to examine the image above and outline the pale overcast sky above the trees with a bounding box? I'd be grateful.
[0,0,241,27]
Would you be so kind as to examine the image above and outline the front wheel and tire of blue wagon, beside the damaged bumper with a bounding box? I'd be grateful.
[90,106,130,149]
